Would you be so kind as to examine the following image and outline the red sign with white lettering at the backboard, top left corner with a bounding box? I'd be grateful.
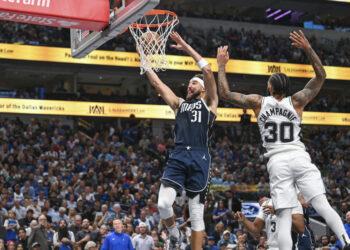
[0,0,109,31]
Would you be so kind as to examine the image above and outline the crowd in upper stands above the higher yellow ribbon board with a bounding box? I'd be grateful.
[0,15,350,66]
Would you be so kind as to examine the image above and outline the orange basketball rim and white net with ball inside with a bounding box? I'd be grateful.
[129,10,179,75]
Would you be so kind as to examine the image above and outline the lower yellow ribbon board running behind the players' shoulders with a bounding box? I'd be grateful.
[0,98,350,126]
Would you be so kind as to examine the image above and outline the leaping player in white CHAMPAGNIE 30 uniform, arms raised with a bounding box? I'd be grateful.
[217,31,350,250]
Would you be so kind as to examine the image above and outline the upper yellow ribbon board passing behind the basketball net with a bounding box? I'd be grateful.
[0,43,350,80]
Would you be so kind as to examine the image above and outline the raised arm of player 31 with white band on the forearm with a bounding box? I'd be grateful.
[170,32,219,113]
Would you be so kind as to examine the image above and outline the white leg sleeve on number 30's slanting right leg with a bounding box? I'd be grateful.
[311,194,350,247]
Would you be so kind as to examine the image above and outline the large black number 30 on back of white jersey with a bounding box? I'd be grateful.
[265,122,294,143]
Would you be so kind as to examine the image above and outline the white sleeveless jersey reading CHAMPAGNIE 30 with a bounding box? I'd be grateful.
[258,96,305,157]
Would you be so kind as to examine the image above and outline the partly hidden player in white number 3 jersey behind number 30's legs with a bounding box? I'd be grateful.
[236,197,305,250]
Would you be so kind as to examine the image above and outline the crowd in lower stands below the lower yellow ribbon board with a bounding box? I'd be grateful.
[0,117,350,250]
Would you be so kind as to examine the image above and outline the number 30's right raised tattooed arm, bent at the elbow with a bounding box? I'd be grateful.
[289,30,326,110]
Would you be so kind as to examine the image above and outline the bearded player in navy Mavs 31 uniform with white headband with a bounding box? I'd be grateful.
[146,32,219,250]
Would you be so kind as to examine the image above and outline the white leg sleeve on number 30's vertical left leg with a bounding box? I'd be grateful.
[276,208,293,250]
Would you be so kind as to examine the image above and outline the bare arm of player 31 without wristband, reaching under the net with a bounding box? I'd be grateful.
[146,63,181,113]
